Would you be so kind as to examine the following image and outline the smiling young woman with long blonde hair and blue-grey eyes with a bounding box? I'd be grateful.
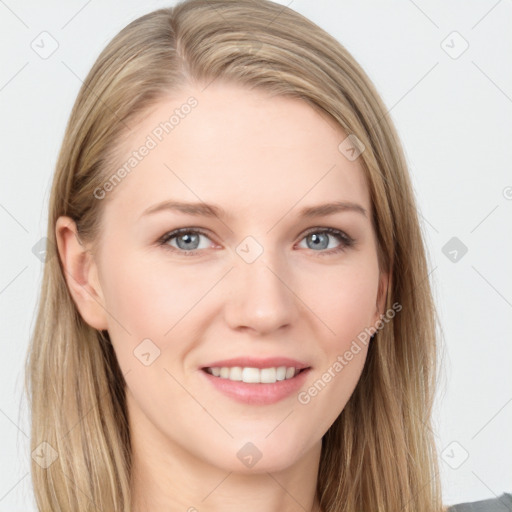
[27,0,508,512]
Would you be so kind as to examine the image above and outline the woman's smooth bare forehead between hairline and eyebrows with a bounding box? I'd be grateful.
[104,82,370,218]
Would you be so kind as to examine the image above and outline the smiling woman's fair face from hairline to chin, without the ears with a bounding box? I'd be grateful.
[63,84,386,472]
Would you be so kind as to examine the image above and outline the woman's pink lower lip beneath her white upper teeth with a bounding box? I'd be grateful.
[201,368,311,405]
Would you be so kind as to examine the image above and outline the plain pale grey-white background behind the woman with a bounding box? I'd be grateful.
[0,0,512,512]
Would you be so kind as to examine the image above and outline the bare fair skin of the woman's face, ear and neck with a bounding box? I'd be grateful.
[56,83,388,512]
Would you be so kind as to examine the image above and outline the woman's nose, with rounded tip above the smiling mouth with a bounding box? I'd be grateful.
[225,247,300,335]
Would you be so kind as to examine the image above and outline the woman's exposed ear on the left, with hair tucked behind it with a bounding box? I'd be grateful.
[55,216,108,330]
